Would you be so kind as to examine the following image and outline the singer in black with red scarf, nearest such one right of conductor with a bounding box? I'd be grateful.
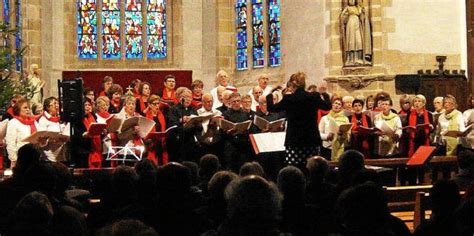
[349,98,373,158]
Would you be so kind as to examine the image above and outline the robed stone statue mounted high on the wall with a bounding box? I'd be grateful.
[340,0,373,66]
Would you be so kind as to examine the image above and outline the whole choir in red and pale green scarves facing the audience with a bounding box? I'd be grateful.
[0,71,474,183]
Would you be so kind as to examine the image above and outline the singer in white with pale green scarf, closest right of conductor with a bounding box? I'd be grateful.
[319,98,352,161]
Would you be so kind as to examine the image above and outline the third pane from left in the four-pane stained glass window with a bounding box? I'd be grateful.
[125,0,143,59]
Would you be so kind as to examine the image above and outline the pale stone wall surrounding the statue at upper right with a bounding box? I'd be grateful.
[325,0,467,109]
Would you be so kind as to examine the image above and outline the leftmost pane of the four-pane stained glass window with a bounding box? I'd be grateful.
[77,0,98,59]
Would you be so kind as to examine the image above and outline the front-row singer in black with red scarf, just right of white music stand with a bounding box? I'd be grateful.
[145,95,168,166]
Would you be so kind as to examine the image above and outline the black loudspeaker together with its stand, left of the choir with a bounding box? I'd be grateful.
[58,78,84,167]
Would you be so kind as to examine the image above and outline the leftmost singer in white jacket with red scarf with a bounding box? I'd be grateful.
[5,98,41,168]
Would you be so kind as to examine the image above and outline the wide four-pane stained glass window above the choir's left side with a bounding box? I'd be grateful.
[76,0,168,59]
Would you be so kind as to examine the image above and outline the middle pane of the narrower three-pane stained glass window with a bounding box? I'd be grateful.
[252,0,265,68]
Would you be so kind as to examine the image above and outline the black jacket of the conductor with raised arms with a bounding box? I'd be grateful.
[267,88,331,147]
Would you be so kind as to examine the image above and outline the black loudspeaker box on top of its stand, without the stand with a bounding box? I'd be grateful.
[58,79,84,123]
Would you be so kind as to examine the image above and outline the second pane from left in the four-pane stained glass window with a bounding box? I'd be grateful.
[102,0,121,59]
